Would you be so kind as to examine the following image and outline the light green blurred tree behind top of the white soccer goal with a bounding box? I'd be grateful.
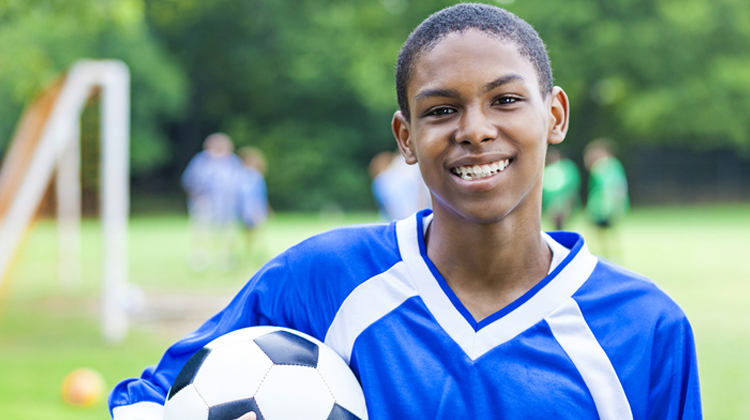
[0,0,186,173]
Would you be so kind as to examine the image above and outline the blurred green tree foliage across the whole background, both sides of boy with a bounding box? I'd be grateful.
[0,0,750,210]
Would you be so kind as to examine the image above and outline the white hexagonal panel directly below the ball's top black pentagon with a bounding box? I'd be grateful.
[255,365,334,420]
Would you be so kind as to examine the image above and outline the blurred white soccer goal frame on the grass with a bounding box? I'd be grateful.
[0,60,130,343]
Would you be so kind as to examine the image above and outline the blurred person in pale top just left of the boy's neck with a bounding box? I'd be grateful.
[369,152,431,222]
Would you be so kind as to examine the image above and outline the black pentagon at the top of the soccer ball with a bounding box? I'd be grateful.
[255,330,318,368]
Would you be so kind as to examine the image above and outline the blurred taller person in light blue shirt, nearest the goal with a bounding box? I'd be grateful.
[181,133,244,272]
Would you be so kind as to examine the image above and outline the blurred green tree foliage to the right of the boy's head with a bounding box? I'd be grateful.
[511,0,750,153]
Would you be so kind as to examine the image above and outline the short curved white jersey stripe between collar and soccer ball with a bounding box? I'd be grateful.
[325,262,417,363]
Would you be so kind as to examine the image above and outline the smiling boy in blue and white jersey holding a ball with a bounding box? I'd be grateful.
[110,4,700,420]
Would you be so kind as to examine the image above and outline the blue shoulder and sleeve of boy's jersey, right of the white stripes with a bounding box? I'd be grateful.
[574,259,700,418]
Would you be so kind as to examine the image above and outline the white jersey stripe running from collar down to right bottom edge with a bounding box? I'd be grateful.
[546,298,633,420]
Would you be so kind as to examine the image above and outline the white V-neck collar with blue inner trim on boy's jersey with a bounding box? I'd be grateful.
[396,211,597,360]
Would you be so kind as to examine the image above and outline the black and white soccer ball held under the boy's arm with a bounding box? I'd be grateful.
[164,326,367,420]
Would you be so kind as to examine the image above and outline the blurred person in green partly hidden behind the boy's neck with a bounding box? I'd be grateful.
[542,147,581,230]
